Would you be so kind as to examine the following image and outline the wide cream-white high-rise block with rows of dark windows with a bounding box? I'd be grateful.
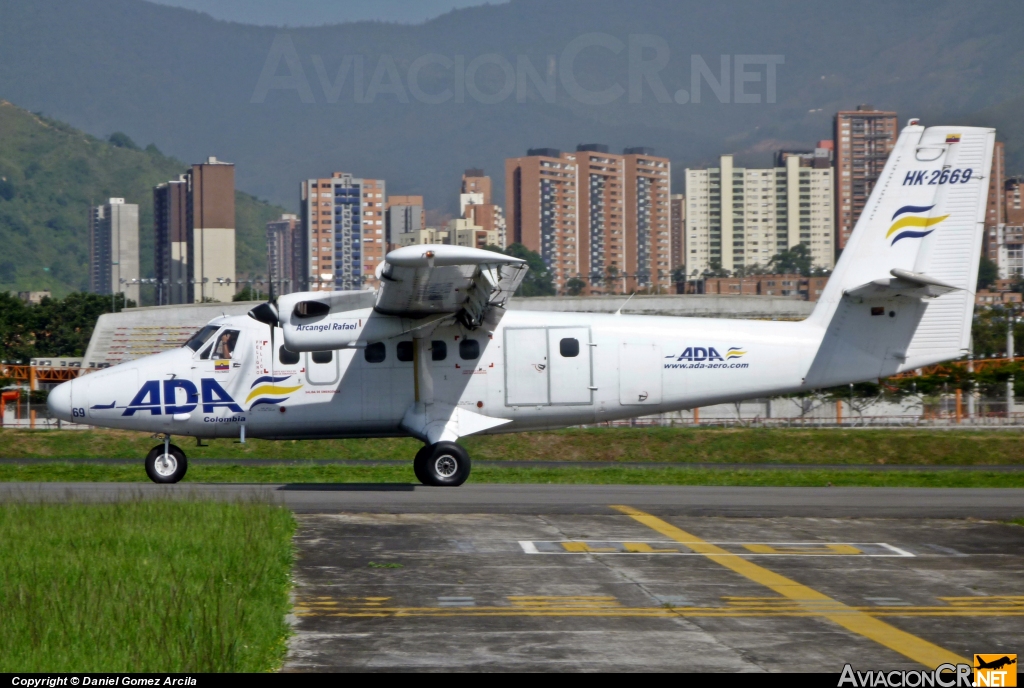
[685,153,836,277]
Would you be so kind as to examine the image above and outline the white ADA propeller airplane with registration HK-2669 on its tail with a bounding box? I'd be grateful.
[49,120,995,485]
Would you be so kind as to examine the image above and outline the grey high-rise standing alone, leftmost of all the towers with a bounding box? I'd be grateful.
[89,199,139,304]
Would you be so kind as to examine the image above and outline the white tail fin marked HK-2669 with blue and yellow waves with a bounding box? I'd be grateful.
[806,124,995,387]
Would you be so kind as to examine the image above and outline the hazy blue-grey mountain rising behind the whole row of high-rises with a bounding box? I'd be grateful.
[0,0,1024,211]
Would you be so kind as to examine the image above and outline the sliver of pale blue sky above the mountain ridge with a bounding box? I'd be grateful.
[148,0,507,27]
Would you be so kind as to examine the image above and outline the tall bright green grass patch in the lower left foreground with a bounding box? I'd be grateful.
[0,501,295,674]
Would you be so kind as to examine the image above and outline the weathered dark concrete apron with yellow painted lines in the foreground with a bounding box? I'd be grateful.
[285,510,1024,674]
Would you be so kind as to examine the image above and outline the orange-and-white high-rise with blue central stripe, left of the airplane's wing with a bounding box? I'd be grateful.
[301,172,387,291]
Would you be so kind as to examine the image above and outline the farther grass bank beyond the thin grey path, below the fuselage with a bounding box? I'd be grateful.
[0,428,1024,465]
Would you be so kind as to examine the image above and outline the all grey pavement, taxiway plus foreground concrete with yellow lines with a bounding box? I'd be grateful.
[0,483,1024,673]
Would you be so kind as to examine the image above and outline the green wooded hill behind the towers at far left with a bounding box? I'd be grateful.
[0,101,285,300]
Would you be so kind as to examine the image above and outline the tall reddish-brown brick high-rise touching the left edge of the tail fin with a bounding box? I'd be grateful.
[834,105,898,249]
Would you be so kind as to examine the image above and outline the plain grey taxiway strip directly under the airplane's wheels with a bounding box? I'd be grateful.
[0,482,1024,519]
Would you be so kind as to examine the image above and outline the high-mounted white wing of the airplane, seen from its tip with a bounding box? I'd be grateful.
[374,244,527,329]
